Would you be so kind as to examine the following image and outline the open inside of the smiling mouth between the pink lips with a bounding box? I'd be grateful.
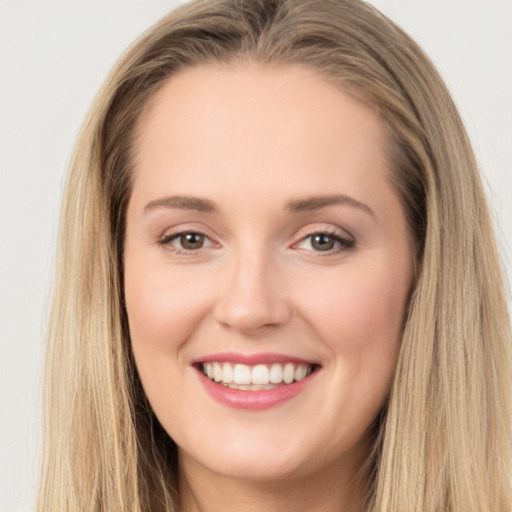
[197,361,318,391]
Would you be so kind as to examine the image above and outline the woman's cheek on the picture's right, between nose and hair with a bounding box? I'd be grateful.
[297,262,409,394]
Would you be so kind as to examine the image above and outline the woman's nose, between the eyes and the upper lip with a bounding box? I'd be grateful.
[214,249,291,334]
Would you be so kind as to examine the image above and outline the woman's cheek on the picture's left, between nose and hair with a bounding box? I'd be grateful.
[125,258,216,432]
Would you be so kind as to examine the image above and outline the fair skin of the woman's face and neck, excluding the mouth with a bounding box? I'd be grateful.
[125,63,413,512]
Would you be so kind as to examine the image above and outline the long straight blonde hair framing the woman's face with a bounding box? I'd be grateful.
[38,0,512,512]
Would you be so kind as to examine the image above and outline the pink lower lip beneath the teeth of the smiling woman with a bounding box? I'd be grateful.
[198,370,318,411]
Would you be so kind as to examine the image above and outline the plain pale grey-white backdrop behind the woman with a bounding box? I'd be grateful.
[0,0,512,512]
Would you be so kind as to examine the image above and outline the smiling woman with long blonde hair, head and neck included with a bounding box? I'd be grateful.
[39,0,511,512]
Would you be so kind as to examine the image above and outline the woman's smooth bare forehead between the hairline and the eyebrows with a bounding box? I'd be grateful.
[130,62,388,208]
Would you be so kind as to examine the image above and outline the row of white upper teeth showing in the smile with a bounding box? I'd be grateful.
[203,362,312,385]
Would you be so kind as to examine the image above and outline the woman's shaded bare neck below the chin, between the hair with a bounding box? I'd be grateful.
[179,448,368,512]
